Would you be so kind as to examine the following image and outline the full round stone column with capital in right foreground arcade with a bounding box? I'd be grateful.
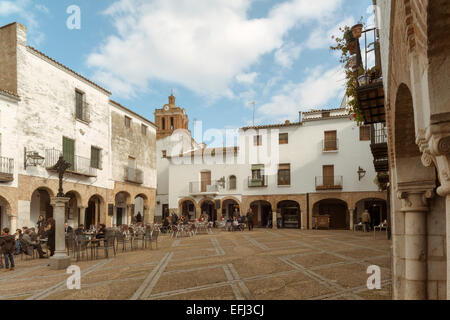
[398,190,432,300]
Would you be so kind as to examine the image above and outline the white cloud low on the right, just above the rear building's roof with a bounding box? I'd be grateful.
[258,66,345,122]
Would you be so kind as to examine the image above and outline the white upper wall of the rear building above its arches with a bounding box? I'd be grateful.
[169,117,378,209]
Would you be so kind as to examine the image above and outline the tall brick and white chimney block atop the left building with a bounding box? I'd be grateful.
[0,22,27,95]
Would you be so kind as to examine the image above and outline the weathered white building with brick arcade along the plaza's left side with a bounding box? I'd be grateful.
[0,23,156,229]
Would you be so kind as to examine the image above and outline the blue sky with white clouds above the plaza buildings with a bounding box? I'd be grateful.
[0,0,373,140]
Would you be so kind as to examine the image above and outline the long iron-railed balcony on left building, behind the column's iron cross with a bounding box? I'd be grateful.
[45,149,97,178]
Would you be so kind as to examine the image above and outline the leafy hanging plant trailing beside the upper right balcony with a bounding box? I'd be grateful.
[330,18,364,125]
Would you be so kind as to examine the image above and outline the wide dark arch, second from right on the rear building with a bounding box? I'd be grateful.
[312,198,350,230]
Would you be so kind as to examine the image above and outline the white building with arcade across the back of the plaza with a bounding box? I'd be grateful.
[155,96,387,229]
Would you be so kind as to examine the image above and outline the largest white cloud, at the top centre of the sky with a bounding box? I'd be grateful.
[88,0,342,96]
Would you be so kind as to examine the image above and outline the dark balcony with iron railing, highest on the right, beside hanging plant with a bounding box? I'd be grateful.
[354,28,386,124]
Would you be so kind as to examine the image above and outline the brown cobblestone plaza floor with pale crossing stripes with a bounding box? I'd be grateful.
[0,229,391,300]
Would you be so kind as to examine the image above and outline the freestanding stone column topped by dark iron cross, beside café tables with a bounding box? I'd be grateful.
[50,197,70,270]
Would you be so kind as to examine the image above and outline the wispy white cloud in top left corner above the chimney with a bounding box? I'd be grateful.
[0,0,45,46]
